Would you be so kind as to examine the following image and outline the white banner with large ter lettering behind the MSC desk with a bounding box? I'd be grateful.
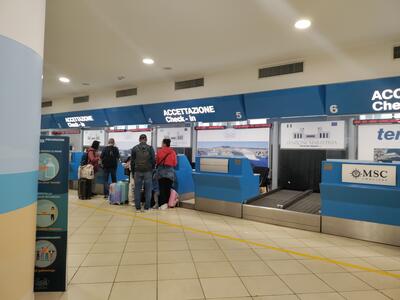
[358,124,400,162]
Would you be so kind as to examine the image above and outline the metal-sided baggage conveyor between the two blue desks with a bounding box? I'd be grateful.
[243,189,321,232]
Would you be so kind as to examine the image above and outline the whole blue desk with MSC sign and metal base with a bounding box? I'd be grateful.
[320,160,400,246]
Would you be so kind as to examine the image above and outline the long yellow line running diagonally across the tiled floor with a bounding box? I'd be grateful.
[70,199,400,279]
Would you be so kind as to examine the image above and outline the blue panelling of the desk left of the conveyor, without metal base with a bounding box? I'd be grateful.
[193,157,259,203]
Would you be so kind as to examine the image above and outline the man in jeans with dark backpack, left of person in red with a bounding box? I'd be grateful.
[131,134,155,211]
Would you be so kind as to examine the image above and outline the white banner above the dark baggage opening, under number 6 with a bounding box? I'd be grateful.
[281,121,345,149]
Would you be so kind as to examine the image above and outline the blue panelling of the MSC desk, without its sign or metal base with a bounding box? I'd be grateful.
[320,161,400,226]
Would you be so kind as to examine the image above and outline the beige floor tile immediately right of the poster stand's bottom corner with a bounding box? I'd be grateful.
[71,266,118,284]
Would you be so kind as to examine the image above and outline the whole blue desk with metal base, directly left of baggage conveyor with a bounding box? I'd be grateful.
[193,157,259,218]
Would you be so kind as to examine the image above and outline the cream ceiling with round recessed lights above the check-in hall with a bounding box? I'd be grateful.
[43,0,400,99]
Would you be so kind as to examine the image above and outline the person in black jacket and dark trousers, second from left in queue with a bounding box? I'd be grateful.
[100,138,120,198]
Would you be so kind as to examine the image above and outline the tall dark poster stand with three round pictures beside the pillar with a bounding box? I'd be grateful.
[34,136,69,292]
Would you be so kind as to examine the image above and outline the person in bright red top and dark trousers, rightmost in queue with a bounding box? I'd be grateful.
[156,139,177,209]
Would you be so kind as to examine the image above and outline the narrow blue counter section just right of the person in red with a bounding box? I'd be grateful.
[175,154,194,200]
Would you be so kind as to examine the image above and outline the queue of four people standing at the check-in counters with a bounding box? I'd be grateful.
[82,134,177,211]
